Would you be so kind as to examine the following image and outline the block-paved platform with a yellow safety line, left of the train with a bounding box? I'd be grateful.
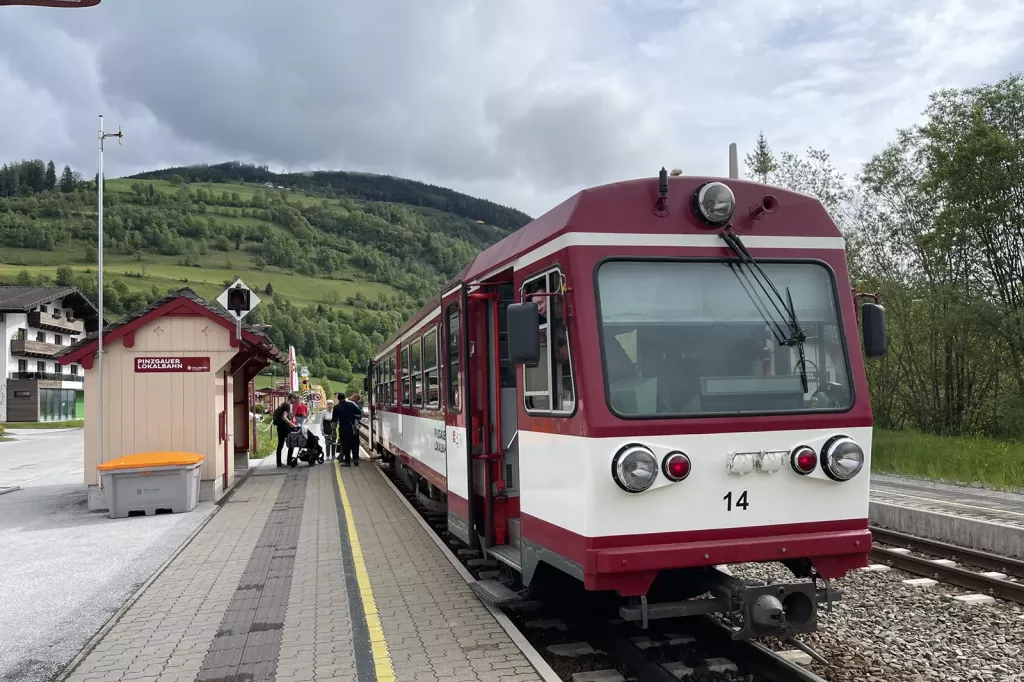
[58,446,550,682]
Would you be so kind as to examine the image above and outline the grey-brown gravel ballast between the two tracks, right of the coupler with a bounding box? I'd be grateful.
[729,564,1024,682]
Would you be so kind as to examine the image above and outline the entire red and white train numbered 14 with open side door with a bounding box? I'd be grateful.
[367,169,886,638]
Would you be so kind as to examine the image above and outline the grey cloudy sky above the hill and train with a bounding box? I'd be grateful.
[0,0,1024,215]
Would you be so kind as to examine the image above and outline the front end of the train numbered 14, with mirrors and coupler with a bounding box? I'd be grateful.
[508,171,886,638]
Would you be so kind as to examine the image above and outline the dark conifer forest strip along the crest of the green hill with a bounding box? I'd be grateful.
[130,161,530,229]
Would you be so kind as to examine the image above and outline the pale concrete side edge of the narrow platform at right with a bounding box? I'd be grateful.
[868,501,1024,559]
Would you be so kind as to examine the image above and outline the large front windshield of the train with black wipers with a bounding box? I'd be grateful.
[597,260,853,417]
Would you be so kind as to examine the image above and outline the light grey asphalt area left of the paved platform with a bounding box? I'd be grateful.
[0,429,214,682]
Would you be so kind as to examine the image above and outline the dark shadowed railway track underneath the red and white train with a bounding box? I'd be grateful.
[362,430,824,682]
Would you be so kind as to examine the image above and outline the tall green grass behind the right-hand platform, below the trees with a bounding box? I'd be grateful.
[871,429,1024,489]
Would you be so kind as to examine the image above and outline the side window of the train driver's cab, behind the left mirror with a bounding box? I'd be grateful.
[523,268,575,414]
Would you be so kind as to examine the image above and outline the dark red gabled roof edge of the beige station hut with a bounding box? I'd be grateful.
[57,288,286,365]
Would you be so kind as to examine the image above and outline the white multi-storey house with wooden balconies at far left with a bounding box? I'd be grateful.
[0,287,99,422]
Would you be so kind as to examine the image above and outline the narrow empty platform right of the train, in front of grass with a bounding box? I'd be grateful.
[869,474,1024,559]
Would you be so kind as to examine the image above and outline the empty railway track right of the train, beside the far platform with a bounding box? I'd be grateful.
[871,526,1024,604]
